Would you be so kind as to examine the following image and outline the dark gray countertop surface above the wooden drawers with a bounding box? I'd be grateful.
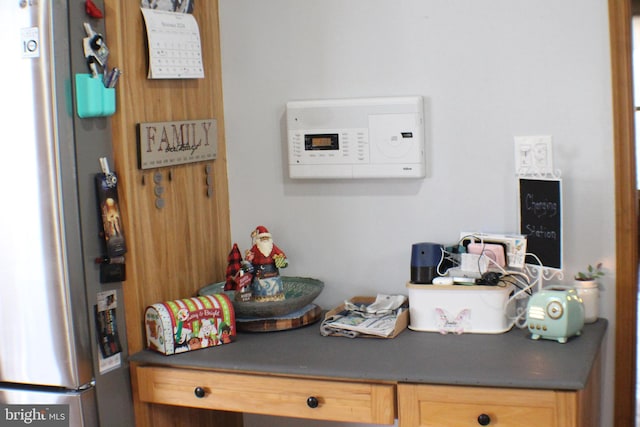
[129,319,607,390]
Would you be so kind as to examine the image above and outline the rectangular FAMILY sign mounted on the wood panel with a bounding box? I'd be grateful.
[138,119,218,169]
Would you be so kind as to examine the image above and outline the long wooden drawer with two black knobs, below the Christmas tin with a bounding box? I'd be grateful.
[136,366,396,424]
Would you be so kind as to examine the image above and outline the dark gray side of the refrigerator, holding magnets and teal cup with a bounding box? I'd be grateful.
[69,0,134,427]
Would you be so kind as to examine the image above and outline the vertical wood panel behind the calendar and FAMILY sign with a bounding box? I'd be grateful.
[105,0,241,426]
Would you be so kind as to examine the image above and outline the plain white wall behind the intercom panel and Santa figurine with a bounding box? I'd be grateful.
[220,0,615,427]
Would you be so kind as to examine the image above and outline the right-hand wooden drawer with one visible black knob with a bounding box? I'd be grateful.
[398,384,578,427]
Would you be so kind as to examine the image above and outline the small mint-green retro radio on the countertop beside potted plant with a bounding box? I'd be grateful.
[527,289,584,344]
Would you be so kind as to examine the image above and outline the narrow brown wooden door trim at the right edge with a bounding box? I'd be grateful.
[609,0,638,426]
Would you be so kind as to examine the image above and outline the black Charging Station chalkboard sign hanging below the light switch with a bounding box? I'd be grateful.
[520,178,562,269]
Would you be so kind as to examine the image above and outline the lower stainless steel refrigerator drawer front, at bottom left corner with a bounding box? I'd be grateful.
[0,388,99,427]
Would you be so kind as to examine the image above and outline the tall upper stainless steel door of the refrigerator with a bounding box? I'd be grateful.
[0,0,93,389]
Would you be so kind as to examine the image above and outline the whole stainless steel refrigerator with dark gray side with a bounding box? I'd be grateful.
[0,0,134,427]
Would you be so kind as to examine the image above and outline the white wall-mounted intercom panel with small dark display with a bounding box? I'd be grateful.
[287,96,426,178]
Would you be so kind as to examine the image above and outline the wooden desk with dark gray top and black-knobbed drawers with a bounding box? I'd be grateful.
[130,319,607,427]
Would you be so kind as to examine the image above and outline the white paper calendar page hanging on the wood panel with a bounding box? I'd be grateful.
[141,8,204,79]
